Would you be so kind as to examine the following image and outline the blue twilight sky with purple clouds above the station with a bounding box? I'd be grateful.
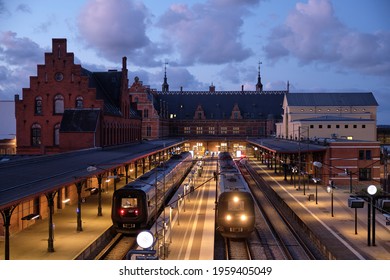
[0,0,390,124]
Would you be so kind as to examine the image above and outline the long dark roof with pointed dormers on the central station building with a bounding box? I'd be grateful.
[158,91,285,120]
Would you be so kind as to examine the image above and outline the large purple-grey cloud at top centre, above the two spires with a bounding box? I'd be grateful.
[157,0,254,65]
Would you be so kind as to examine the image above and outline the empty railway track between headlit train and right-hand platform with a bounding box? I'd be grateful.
[241,160,322,260]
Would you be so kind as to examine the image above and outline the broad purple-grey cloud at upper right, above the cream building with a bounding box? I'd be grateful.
[264,0,390,75]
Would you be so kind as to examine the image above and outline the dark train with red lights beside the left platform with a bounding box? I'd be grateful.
[111,152,192,234]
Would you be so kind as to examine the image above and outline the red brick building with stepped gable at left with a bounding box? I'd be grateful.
[15,39,141,154]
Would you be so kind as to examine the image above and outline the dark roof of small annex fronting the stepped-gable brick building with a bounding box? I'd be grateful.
[60,109,100,132]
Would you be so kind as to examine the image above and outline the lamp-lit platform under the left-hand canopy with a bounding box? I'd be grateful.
[0,189,112,260]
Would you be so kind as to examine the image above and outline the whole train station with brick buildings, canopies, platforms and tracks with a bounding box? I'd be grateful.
[0,38,390,260]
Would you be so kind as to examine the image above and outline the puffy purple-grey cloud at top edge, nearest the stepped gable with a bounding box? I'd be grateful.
[77,0,157,62]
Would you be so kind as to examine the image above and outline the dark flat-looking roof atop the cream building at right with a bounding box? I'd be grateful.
[286,92,378,106]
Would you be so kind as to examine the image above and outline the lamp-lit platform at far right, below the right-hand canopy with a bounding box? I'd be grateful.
[252,160,390,260]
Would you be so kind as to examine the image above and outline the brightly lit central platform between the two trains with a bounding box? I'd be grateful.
[148,160,216,260]
